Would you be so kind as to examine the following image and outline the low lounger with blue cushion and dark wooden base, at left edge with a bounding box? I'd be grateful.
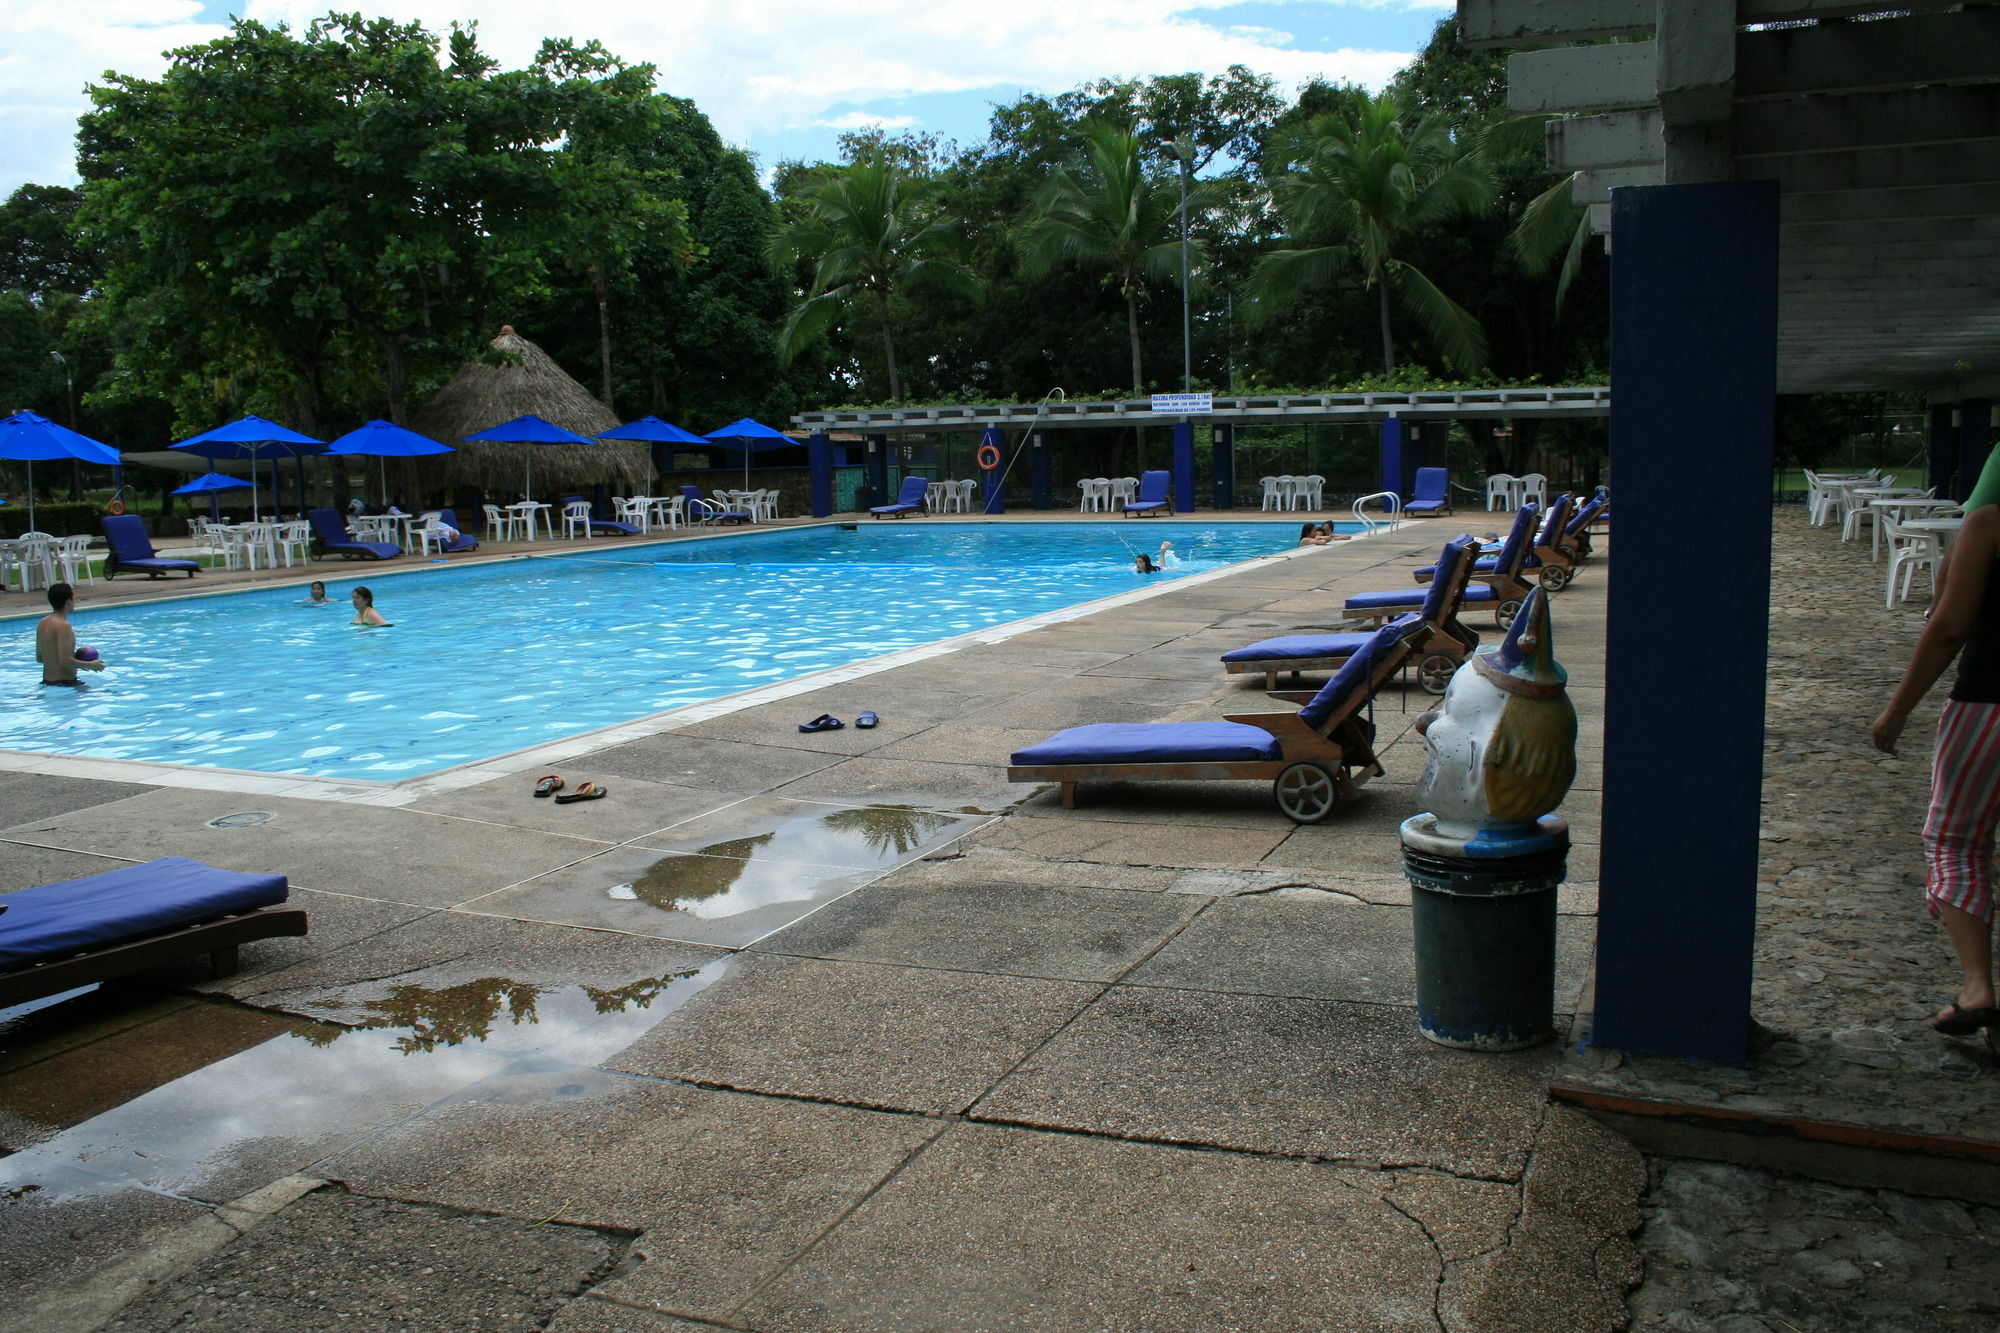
[0,857,306,1009]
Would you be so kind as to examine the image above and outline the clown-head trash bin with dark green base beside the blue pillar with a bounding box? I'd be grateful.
[1402,588,1576,1051]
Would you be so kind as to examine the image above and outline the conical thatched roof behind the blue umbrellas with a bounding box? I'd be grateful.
[410,324,652,492]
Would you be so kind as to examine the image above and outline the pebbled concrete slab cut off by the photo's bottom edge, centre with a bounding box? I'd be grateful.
[740,1125,1440,1333]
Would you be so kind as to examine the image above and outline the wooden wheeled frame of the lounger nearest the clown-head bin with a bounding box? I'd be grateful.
[1006,628,1418,825]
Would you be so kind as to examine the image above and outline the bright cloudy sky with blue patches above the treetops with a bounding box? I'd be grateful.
[0,0,1454,194]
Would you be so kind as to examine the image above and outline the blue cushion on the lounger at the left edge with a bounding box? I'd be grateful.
[0,857,290,971]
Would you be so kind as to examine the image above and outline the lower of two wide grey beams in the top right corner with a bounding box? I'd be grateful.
[1734,84,2000,160]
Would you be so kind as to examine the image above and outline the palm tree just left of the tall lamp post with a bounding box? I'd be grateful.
[1018,120,1210,392]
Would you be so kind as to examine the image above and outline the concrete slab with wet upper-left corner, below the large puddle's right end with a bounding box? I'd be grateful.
[320,1069,942,1319]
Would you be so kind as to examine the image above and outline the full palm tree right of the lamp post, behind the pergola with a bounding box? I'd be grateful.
[1252,92,1494,374]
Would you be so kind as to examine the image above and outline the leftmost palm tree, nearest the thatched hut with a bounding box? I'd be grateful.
[772,154,978,402]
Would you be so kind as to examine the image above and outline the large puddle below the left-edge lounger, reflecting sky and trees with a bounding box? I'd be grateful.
[0,959,728,1209]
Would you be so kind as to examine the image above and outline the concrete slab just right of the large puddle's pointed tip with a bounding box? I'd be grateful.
[606,953,1102,1115]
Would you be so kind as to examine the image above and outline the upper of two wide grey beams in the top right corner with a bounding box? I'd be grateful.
[1736,10,2000,98]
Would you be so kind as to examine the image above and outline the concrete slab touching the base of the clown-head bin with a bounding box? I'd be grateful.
[972,987,1556,1179]
